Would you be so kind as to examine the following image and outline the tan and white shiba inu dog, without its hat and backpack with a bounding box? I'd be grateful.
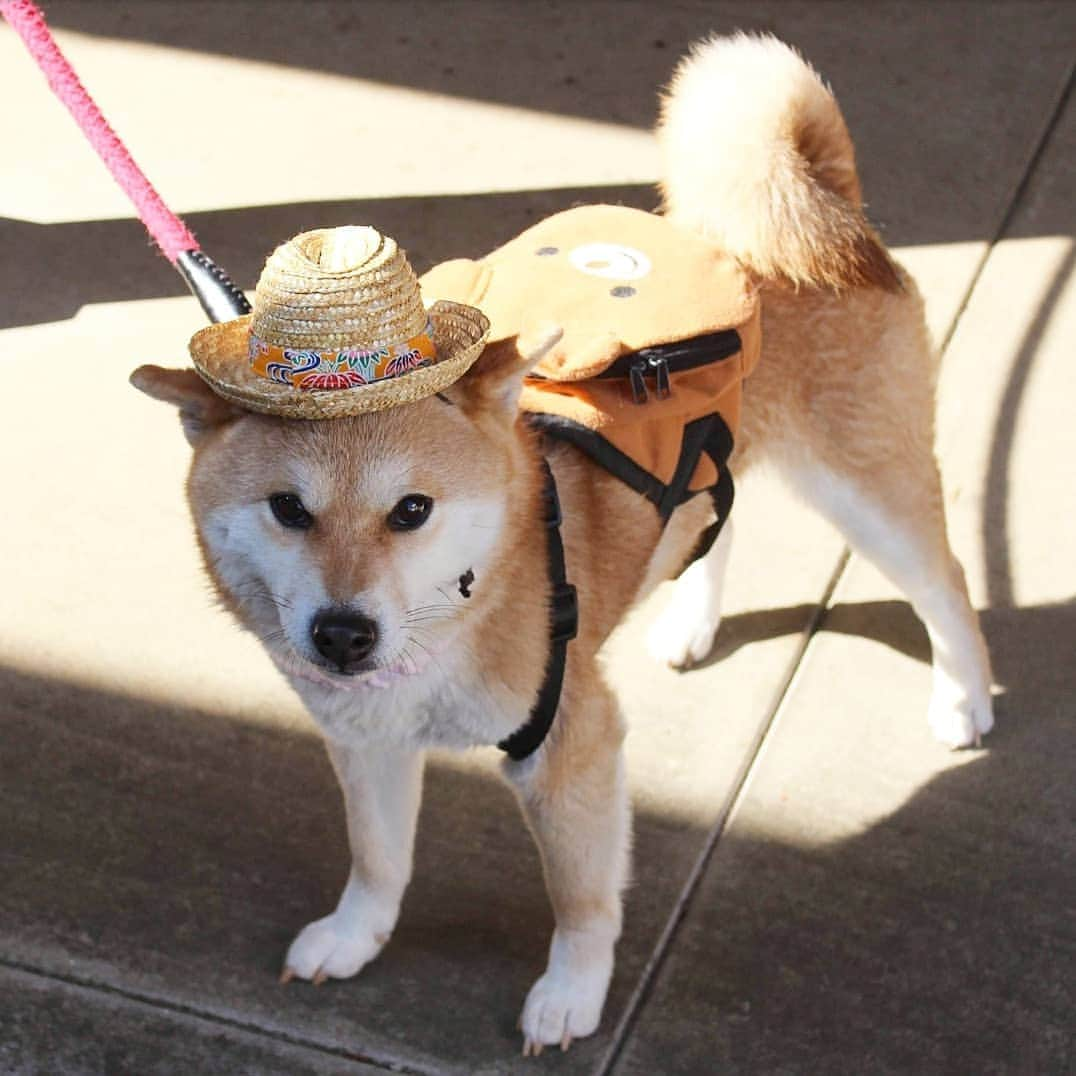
[133,36,993,1052]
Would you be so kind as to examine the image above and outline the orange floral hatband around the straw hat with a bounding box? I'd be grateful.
[247,322,437,390]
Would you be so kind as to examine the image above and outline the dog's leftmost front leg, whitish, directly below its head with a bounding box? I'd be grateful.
[281,740,423,982]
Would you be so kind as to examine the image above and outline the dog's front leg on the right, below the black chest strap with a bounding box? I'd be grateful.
[505,675,631,1054]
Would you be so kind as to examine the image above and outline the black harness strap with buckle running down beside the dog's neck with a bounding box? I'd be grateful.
[497,459,579,762]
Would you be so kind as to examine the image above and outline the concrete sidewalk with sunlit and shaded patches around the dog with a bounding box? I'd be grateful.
[0,0,1076,1076]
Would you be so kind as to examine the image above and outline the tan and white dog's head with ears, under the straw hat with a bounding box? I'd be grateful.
[131,328,560,686]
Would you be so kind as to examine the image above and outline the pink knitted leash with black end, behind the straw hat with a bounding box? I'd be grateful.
[0,0,251,322]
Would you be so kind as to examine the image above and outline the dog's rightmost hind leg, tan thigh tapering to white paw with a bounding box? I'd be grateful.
[775,441,994,748]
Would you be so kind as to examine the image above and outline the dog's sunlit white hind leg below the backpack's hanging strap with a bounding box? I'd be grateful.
[647,519,733,669]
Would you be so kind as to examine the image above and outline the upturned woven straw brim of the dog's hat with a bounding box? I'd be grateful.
[190,300,490,419]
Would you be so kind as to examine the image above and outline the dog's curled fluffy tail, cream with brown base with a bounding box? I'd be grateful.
[657,33,901,288]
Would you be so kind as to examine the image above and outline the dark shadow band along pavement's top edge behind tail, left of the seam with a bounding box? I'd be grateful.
[25,0,1076,252]
